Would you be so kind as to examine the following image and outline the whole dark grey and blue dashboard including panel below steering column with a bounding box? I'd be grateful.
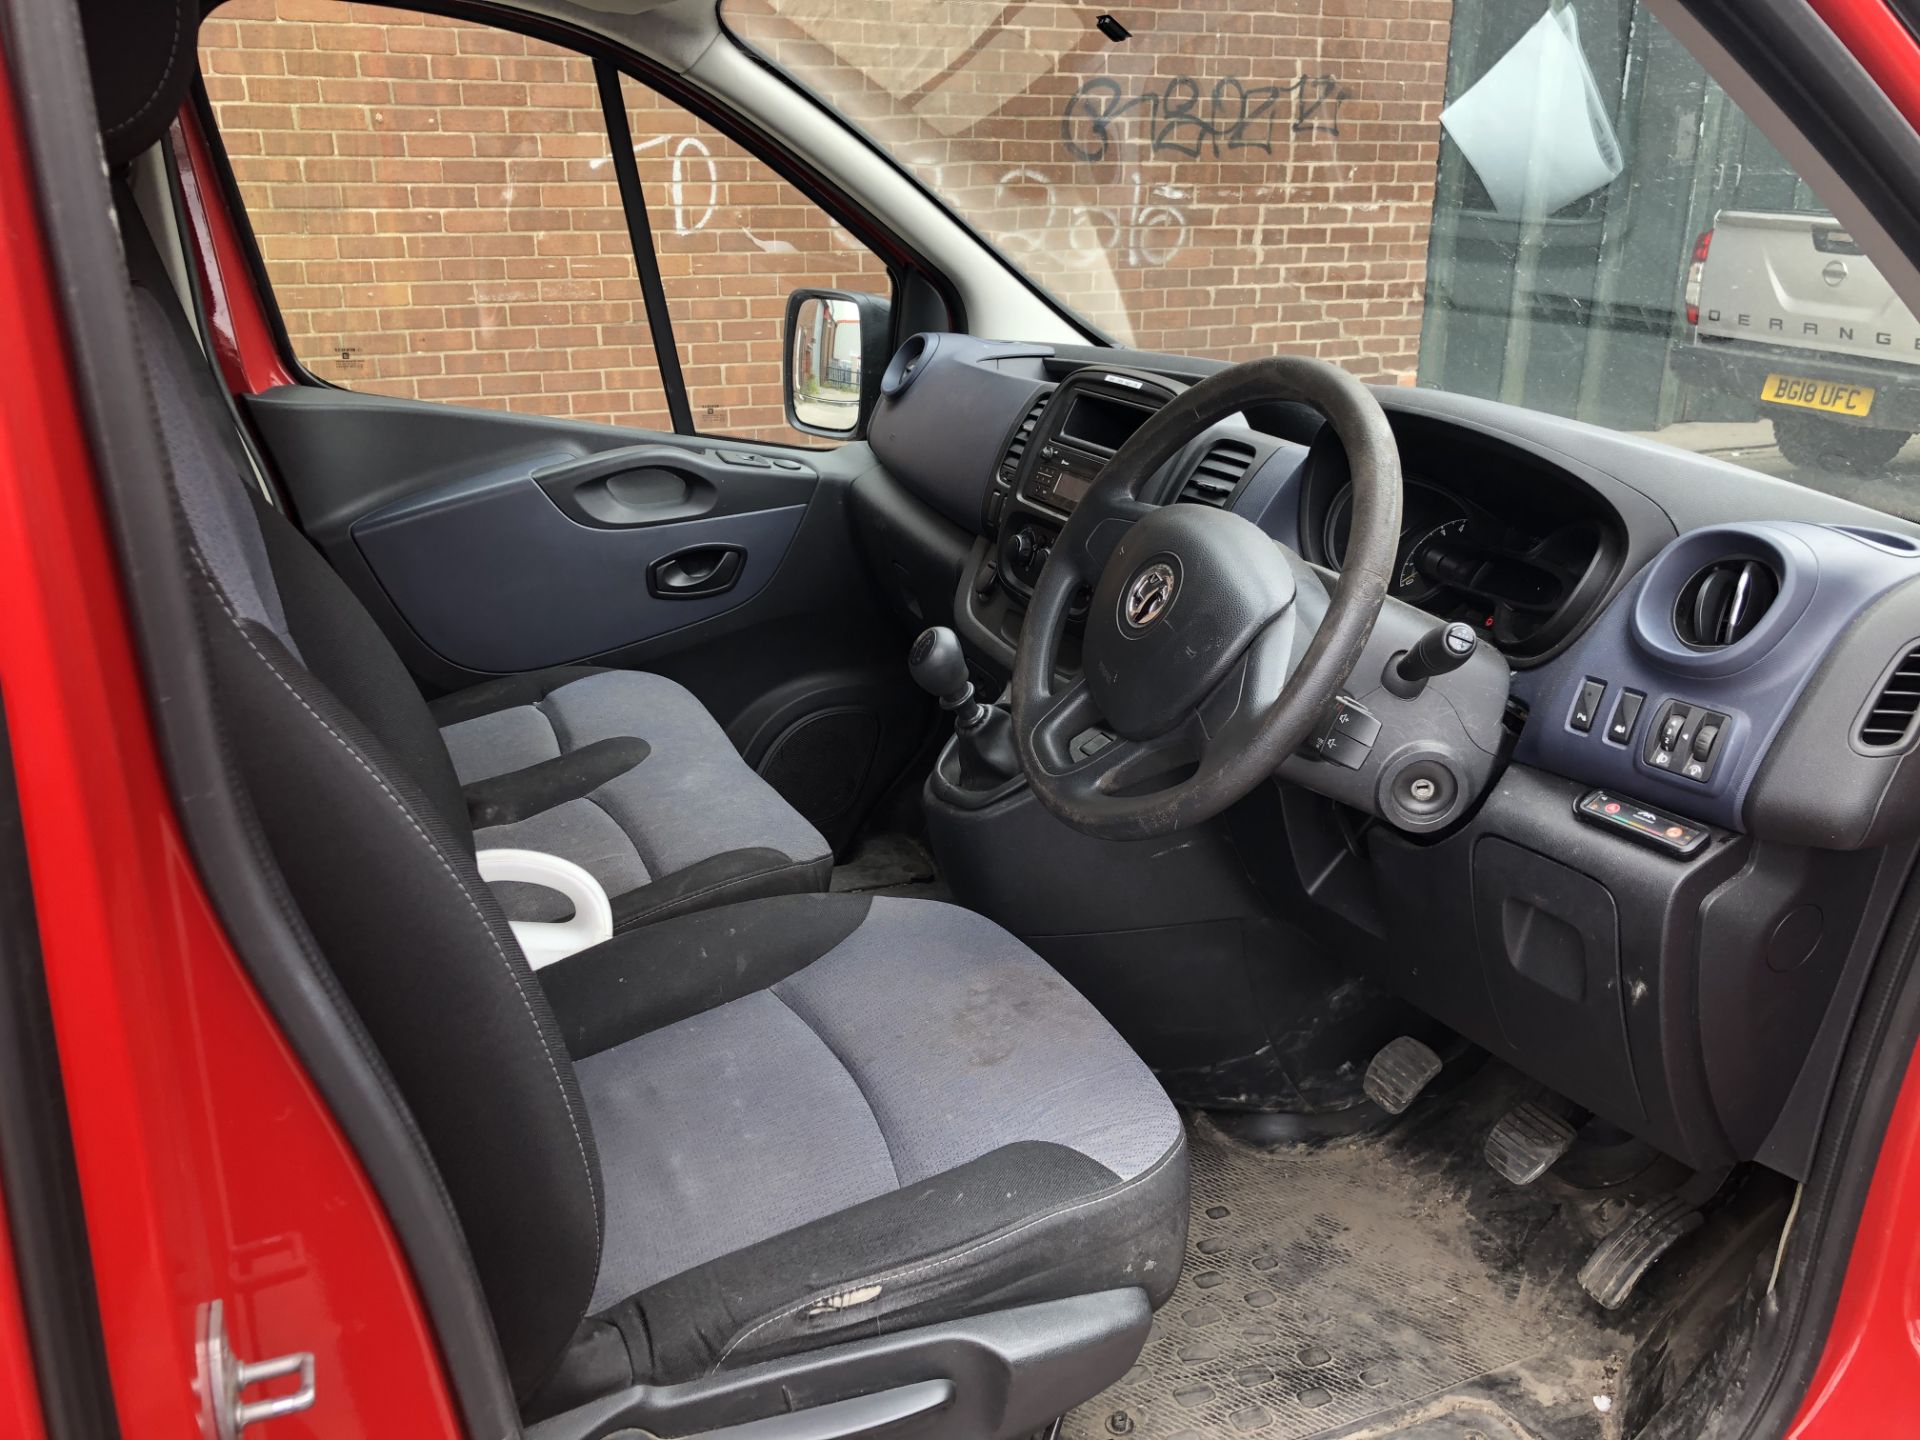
[852,334,1920,1173]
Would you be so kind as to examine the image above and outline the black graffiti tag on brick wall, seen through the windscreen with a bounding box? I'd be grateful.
[1060,75,1352,161]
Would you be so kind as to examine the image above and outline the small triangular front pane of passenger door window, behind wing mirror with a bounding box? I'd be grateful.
[620,79,893,444]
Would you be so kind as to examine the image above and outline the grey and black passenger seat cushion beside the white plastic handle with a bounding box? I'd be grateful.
[434,666,833,929]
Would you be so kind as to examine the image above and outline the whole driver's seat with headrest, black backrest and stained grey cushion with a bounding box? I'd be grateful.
[88,0,1187,1436]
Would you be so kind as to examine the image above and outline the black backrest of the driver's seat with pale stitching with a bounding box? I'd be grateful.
[123,242,603,1396]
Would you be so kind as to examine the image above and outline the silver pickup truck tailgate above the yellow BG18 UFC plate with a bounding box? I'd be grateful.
[1697,209,1920,367]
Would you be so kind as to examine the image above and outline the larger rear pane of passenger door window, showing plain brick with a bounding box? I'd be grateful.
[202,0,672,428]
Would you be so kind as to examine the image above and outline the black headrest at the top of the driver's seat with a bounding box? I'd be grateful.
[81,0,200,169]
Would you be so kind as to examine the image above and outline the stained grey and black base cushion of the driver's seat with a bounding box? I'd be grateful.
[549,895,1187,1382]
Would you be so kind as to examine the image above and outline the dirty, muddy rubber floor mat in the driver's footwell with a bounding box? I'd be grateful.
[1062,1066,1681,1440]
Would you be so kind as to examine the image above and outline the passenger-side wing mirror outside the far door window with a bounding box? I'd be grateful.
[781,290,893,440]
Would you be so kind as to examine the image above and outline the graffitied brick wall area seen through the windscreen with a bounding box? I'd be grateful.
[724,0,1452,380]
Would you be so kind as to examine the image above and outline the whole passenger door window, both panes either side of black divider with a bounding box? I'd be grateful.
[200,0,891,444]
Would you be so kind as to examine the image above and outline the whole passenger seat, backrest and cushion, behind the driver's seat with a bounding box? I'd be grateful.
[115,200,833,931]
